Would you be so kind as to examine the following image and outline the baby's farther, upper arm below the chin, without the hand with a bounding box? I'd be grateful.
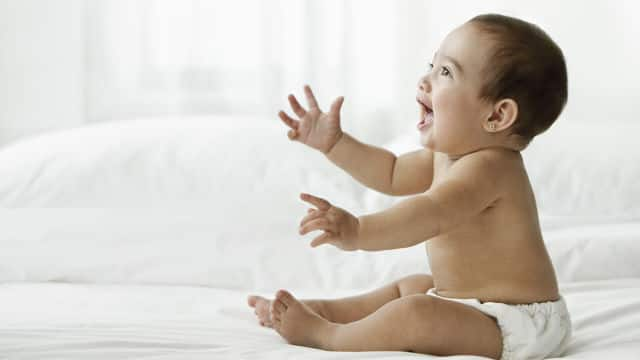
[326,132,433,196]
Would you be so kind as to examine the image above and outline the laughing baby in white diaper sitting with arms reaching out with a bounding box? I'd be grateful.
[248,14,571,359]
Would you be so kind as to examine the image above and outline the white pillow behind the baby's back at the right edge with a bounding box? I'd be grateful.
[523,120,640,221]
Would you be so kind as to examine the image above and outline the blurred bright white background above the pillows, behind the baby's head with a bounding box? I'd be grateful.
[0,0,640,144]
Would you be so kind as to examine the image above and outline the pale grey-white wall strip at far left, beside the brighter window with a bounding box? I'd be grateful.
[0,0,85,144]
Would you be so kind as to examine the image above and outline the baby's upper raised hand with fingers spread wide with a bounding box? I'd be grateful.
[278,85,344,154]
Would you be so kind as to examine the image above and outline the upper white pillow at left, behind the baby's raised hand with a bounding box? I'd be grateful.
[0,116,362,210]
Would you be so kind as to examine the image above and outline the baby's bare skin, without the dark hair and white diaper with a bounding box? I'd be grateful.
[248,20,559,358]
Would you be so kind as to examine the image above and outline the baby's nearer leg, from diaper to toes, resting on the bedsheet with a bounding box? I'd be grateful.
[273,290,502,359]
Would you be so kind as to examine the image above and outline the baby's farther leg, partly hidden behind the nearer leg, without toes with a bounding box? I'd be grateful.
[302,274,433,324]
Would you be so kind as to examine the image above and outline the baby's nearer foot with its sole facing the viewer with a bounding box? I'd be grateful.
[270,290,331,348]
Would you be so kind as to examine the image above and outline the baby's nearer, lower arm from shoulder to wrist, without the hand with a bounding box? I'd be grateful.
[357,152,502,251]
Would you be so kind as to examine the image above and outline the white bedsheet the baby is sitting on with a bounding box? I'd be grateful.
[0,279,640,359]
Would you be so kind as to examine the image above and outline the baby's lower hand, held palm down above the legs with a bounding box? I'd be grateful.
[300,193,360,251]
